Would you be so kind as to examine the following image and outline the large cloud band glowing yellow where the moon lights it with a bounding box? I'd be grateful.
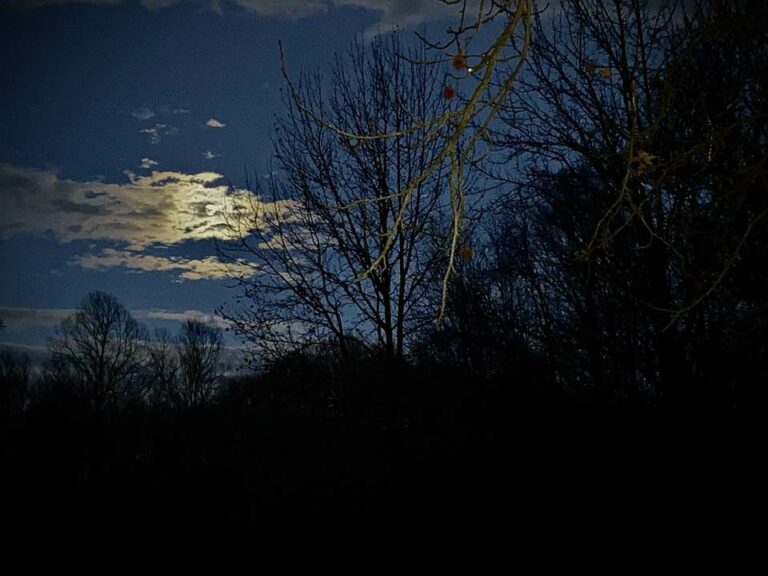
[0,163,292,251]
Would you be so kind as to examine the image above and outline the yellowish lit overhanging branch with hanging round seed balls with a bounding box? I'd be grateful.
[281,0,534,319]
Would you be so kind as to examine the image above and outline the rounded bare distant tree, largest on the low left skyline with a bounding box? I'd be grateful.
[50,292,146,408]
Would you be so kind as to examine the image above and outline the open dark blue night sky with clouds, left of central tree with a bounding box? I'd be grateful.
[0,0,452,347]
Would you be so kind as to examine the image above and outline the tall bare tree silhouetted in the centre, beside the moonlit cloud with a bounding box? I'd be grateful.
[221,37,466,358]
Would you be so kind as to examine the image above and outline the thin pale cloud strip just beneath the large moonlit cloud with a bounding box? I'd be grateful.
[70,248,254,281]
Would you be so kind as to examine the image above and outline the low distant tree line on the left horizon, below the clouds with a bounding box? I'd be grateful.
[0,292,225,412]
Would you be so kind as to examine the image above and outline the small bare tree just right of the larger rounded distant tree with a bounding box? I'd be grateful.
[178,320,224,408]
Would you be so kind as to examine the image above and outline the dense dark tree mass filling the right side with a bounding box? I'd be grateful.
[428,0,768,405]
